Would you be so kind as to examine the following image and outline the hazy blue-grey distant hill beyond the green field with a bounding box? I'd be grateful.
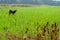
[0,0,60,5]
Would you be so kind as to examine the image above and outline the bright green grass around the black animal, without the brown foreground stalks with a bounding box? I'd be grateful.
[0,6,60,40]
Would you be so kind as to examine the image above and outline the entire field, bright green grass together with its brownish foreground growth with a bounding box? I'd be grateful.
[0,6,60,40]
